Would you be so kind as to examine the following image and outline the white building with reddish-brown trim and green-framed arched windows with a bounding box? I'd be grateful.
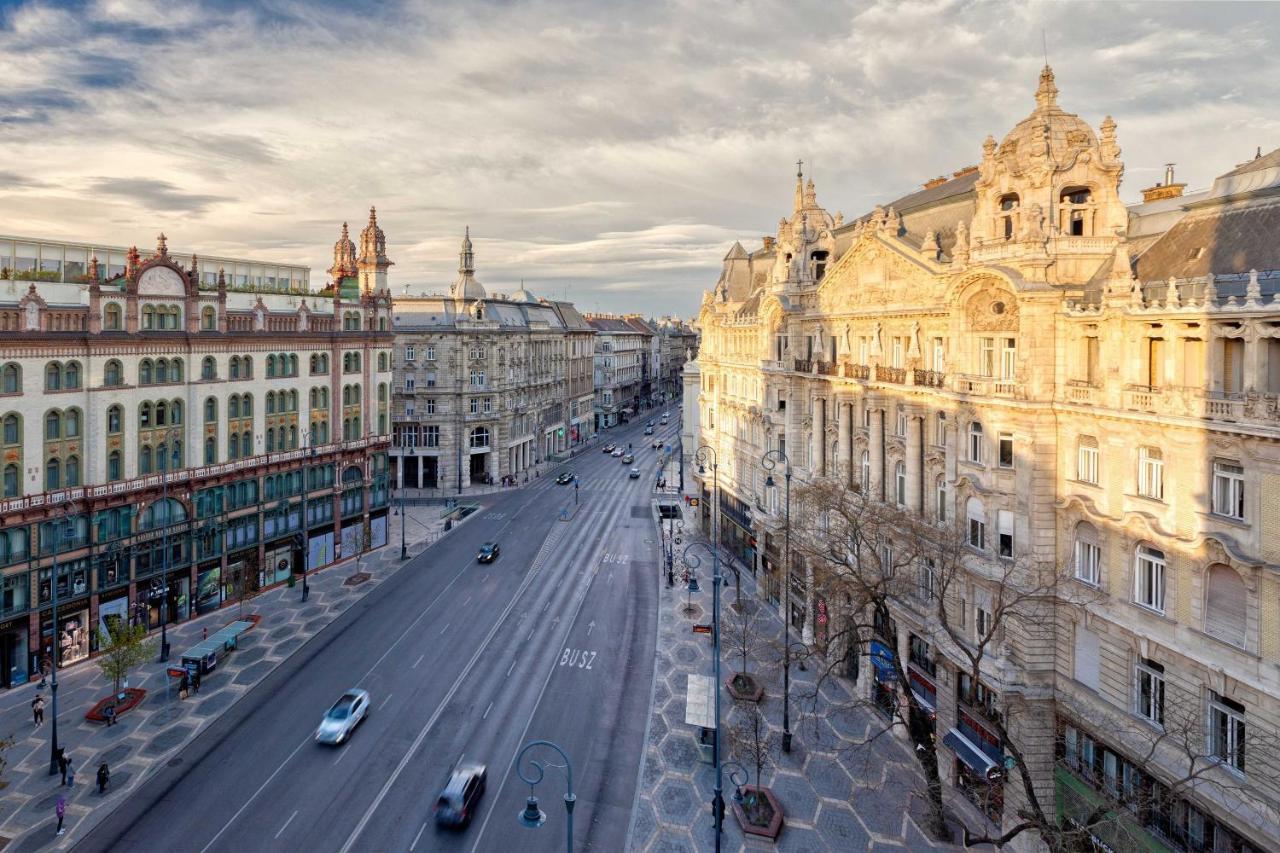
[0,210,392,686]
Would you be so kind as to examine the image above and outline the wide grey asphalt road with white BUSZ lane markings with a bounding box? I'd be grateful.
[76,412,678,853]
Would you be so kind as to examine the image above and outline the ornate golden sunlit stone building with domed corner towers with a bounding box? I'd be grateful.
[685,67,1280,850]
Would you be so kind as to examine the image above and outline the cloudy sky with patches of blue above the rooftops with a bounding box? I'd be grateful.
[0,0,1280,315]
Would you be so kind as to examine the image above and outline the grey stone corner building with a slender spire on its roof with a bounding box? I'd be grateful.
[392,229,595,493]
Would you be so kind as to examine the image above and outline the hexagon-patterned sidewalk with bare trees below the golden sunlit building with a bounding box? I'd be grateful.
[628,502,957,853]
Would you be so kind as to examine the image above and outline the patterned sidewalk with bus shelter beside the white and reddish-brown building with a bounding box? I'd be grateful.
[0,502,471,853]
